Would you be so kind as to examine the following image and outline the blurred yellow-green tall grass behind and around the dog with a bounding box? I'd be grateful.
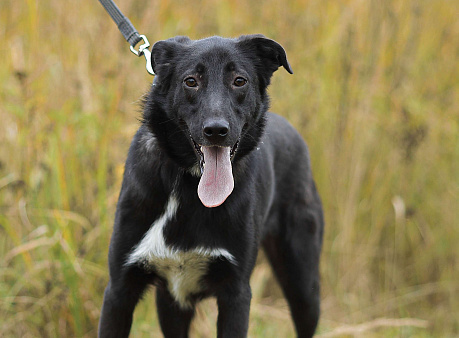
[0,0,459,337]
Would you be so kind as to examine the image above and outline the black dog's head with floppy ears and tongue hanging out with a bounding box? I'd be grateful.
[144,35,292,207]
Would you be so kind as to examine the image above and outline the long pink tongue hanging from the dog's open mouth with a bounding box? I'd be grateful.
[198,147,234,208]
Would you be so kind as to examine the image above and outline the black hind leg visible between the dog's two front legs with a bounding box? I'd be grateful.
[156,288,194,338]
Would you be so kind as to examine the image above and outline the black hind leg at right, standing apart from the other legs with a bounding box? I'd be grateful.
[263,193,323,337]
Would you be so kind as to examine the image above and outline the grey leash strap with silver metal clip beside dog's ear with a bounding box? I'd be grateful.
[99,0,155,75]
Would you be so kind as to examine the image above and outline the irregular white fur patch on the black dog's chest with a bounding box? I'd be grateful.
[126,193,236,308]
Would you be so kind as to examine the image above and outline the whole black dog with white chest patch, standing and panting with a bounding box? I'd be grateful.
[99,35,323,338]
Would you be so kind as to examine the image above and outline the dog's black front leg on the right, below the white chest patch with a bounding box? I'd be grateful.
[217,282,252,338]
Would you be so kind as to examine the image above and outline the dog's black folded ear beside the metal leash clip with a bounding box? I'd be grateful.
[151,36,191,78]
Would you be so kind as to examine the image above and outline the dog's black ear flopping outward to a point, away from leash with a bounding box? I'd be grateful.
[237,34,293,84]
